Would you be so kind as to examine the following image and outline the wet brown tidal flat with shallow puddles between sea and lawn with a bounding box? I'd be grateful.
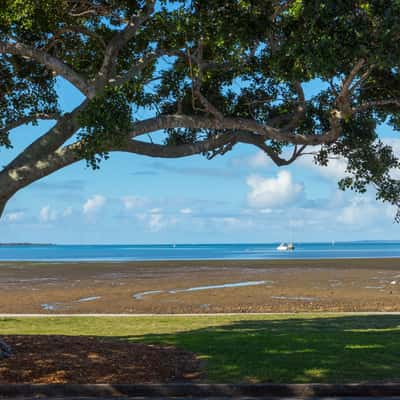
[0,259,400,314]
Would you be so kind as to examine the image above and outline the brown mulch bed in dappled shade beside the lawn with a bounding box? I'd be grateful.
[0,335,200,384]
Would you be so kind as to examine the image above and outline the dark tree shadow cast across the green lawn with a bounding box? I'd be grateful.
[111,315,400,383]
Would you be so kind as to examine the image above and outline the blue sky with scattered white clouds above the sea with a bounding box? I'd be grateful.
[0,76,400,244]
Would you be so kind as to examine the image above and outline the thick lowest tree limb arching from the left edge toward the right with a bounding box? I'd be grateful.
[0,107,340,209]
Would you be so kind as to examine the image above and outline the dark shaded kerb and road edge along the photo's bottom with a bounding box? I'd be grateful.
[0,383,400,400]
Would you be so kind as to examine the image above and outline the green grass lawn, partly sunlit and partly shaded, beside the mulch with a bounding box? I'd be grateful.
[0,314,400,383]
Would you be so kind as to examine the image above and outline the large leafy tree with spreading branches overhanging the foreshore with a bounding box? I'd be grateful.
[0,0,400,219]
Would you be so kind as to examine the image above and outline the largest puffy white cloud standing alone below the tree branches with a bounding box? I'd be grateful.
[246,170,303,209]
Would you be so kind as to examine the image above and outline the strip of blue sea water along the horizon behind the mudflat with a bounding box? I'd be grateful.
[0,241,400,261]
